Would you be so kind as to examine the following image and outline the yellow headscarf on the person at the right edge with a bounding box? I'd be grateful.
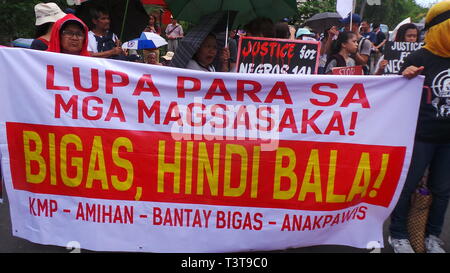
[424,0,450,58]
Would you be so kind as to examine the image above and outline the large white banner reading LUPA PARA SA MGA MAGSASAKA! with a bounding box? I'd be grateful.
[0,48,423,252]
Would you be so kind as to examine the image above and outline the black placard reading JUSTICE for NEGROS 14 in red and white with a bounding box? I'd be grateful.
[237,36,320,75]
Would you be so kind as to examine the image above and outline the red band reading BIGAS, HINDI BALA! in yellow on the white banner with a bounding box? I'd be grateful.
[6,123,406,211]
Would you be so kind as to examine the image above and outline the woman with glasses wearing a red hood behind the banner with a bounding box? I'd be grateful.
[47,14,90,56]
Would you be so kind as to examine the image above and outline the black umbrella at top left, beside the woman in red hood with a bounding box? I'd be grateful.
[75,0,149,41]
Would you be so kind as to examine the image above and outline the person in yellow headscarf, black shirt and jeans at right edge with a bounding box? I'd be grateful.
[389,0,450,253]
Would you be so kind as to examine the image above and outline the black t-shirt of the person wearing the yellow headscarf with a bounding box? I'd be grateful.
[400,48,450,143]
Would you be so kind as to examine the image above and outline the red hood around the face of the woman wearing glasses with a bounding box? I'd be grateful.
[47,14,90,56]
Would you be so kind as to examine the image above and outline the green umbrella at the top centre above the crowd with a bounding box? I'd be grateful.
[165,0,297,26]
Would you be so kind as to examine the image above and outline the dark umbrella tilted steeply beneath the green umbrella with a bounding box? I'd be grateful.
[171,11,227,68]
